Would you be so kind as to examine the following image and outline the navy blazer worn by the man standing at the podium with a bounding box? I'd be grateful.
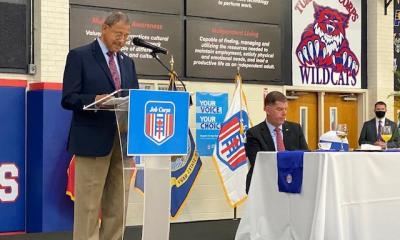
[61,40,139,156]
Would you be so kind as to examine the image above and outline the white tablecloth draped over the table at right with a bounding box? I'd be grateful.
[235,152,400,240]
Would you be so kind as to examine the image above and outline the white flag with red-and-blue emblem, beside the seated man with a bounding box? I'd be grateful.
[213,73,249,207]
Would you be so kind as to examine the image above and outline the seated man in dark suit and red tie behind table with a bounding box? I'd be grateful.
[245,91,308,193]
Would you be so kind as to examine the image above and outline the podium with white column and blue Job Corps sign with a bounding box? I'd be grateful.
[84,89,189,240]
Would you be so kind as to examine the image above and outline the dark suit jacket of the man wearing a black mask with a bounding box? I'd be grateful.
[358,118,400,148]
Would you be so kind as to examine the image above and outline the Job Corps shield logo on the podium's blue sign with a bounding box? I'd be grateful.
[144,101,175,145]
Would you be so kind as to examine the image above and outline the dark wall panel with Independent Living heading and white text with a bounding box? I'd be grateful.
[186,19,281,82]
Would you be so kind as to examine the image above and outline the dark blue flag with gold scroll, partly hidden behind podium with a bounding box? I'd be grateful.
[168,72,202,219]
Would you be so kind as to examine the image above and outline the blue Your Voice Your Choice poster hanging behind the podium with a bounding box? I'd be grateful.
[196,92,228,156]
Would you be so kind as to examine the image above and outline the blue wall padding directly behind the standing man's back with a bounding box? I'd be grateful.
[26,90,73,232]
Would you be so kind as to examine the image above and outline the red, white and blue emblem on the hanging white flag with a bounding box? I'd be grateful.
[216,111,248,171]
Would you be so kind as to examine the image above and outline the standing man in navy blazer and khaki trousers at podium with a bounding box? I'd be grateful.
[62,12,138,240]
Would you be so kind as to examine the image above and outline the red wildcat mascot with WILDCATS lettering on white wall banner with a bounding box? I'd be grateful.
[296,2,360,86]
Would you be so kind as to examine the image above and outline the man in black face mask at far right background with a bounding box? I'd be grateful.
[358,101,400,149]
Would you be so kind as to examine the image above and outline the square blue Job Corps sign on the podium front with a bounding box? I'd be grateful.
[127,90,189,156]
